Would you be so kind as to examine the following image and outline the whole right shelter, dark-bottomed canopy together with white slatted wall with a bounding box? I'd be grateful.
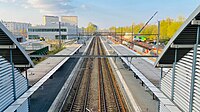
[155,6,200,112]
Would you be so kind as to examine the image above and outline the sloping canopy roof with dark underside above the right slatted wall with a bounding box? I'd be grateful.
[154,6,200,67]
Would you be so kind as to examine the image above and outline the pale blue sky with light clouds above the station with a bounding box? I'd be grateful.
[0,0,200,28]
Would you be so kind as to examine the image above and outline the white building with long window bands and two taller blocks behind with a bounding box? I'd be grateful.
[28,16,77,39]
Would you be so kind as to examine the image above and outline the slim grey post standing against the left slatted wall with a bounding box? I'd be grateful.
[10,48,17,101]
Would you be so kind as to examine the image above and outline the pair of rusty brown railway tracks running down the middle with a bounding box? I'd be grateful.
[62,37,128,112]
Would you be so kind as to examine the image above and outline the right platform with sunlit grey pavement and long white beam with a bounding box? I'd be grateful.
[103,38,181,112]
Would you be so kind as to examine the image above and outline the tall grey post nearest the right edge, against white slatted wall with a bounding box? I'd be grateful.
[189,26,200,112]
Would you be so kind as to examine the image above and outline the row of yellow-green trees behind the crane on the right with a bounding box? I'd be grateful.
[109,16,185,42]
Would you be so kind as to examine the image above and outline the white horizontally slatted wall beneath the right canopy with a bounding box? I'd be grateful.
[161,48,200,112]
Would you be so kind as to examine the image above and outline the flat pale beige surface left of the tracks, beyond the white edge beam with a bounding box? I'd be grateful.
[27,44,82,86]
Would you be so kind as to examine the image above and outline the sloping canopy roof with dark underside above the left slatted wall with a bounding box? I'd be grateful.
[0,22,34,68]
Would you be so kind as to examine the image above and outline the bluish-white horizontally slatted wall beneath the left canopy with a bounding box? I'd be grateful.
[0,56,28,112]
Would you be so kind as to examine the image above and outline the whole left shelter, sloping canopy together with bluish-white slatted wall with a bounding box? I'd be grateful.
[0,22,34,112]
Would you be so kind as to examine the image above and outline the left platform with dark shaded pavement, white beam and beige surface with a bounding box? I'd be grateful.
[5,44,82,112]
